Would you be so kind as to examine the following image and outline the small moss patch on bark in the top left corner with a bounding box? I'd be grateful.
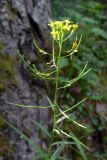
[7,2,17,22]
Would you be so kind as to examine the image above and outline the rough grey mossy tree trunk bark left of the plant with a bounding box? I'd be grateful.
[0,0,51,160]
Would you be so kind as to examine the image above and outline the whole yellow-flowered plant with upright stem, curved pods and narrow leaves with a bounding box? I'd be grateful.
[7,19,91,160]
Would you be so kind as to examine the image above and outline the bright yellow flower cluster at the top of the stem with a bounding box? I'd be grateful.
[48,19,78,41]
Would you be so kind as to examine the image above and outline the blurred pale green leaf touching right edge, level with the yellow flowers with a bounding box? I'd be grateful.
[91,27,107,40]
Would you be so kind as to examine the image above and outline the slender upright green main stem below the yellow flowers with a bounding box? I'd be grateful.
[48,40,62,160]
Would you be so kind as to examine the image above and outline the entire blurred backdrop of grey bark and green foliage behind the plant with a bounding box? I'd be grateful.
[0,0,107,160]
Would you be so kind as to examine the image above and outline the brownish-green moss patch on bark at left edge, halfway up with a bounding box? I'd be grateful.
[0,55,17,91]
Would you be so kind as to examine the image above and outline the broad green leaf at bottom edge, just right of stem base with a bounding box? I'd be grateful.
[50,143,65,160]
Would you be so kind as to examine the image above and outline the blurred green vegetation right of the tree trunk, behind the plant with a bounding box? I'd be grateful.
[52,0,107,160]
